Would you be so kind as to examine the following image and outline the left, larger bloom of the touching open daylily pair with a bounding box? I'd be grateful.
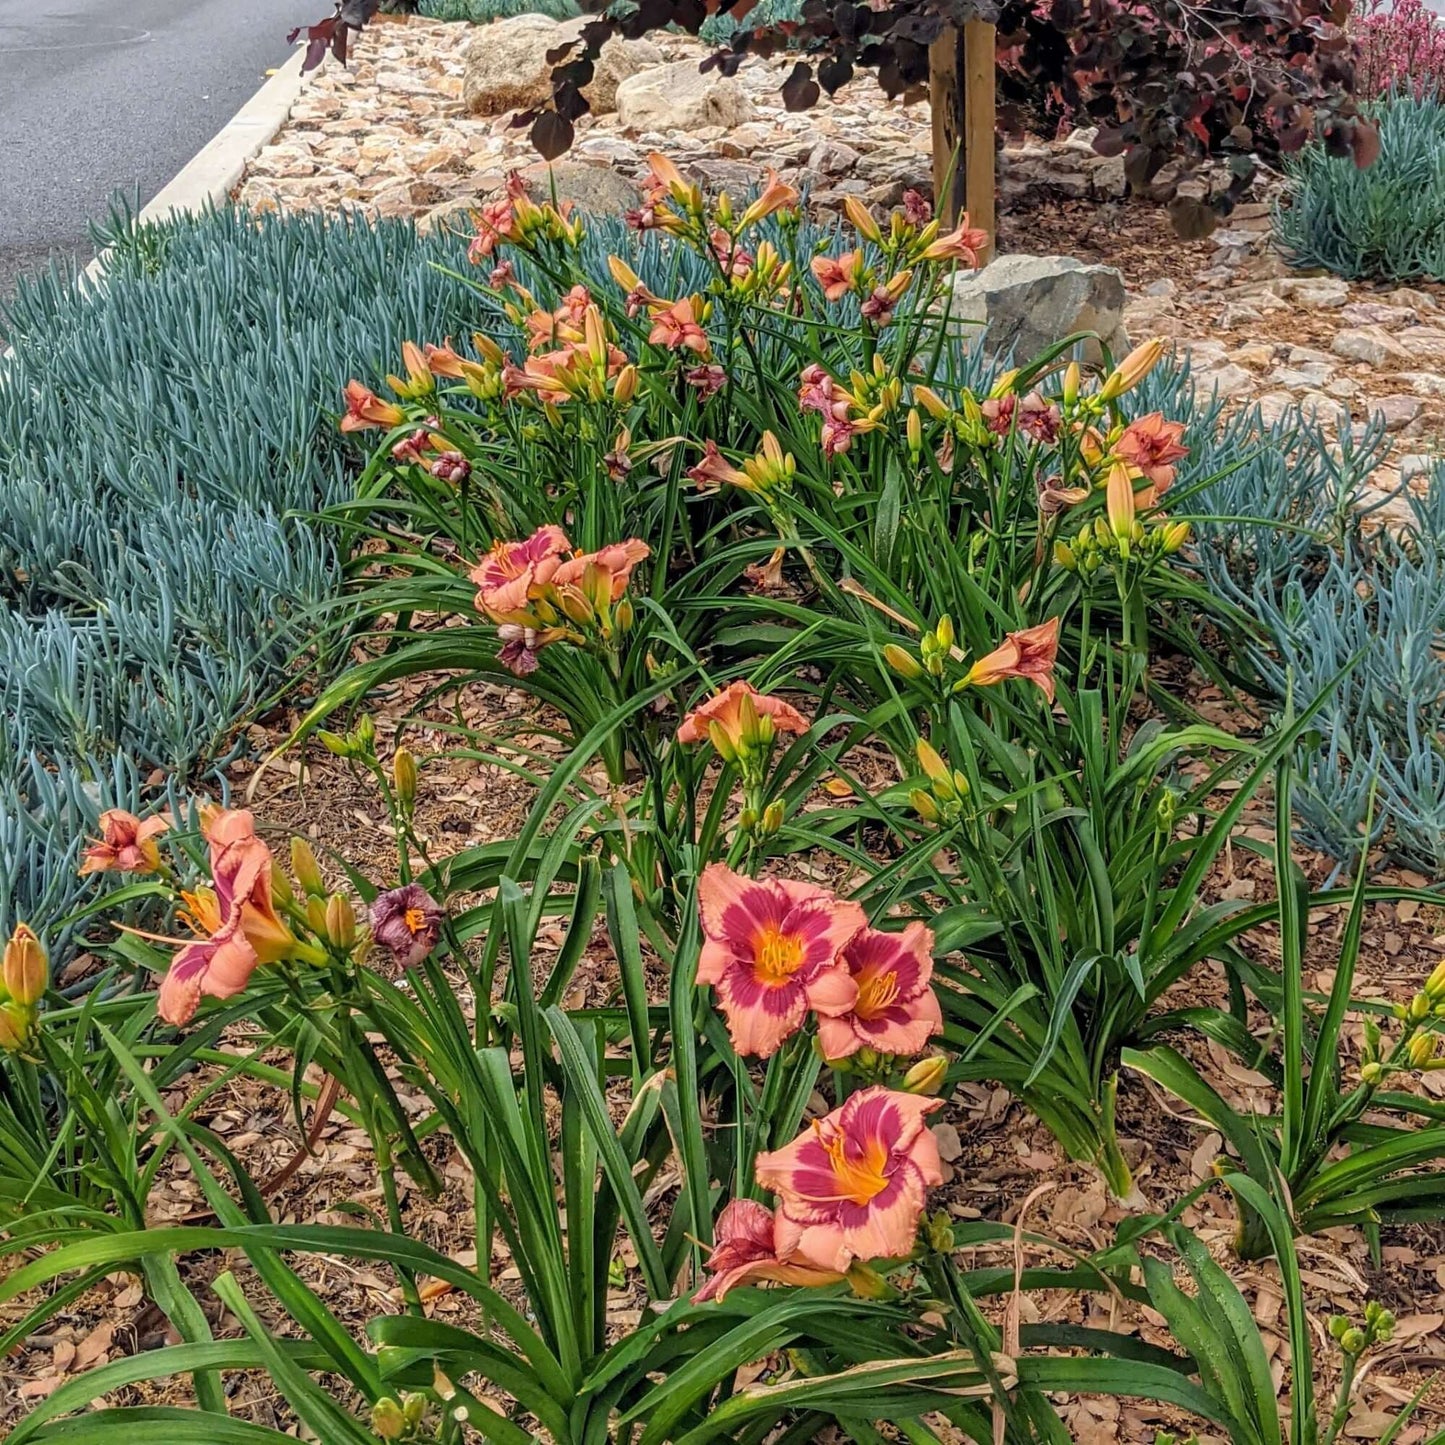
[698,863,867,1059]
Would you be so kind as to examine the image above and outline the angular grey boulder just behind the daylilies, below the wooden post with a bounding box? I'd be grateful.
[948,256,1129,364]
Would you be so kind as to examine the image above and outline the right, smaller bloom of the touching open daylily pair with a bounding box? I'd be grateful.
[818,923,944,1059]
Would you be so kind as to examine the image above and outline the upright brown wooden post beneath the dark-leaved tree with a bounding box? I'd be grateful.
[928,20,997,260]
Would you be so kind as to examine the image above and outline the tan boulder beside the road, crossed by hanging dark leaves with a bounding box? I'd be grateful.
[461,14,662,116]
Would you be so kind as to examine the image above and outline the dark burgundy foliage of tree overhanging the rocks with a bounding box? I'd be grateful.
[284,0,1377,234]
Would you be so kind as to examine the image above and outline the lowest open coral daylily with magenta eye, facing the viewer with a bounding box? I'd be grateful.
[754,1085,944,1270]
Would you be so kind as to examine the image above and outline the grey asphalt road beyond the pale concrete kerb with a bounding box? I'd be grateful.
[0,0,304,299]
